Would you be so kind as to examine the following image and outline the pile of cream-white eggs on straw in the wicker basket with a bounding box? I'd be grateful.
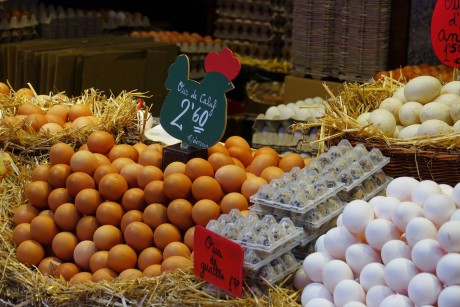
[357,76,460,139]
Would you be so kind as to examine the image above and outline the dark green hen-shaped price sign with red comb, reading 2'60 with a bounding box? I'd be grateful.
[160,48,241,149]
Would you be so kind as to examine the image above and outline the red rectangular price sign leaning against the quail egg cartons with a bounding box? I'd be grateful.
[193,225,244,297]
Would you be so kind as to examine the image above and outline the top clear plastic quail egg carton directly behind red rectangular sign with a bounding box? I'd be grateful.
[206,209,302,253]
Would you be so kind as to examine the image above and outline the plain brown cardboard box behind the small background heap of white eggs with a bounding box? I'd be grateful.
[284,76,342,103]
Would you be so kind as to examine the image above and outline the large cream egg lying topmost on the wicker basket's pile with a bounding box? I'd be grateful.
[404,76,442,104]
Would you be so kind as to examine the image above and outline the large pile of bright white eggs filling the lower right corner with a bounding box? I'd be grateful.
[294,177,460,307]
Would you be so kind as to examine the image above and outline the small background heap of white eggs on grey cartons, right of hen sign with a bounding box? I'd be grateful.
[259,96,325,122]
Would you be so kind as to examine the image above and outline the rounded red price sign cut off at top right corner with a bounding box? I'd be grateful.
[431,0,460,67]
